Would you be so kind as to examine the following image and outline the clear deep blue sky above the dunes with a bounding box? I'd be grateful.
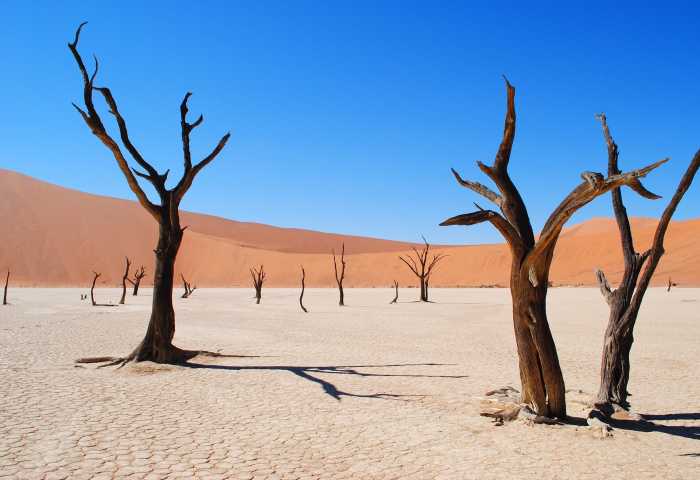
[0,0,700,243]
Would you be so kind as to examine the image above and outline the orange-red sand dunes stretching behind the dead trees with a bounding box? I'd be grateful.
[0,169,700,287]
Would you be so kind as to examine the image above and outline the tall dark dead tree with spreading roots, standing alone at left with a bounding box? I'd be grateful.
[68,23,230,365]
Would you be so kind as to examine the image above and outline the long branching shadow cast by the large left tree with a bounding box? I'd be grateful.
[183,362,467,401]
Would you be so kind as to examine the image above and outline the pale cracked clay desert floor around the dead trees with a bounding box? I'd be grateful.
[0,288,700,479]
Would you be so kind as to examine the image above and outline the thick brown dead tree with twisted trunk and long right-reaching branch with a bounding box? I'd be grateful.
[440,80,666,418]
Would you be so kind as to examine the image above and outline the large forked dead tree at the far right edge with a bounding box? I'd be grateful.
[595,114,700,414]
